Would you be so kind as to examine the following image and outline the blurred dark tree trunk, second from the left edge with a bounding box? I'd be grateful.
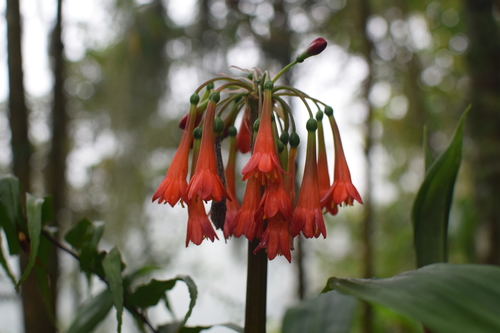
[46,0,68,326]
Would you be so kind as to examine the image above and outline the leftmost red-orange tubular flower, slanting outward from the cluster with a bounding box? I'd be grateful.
[152,100,198,207]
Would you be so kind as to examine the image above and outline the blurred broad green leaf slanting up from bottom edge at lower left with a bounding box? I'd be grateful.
[66,289,113,333]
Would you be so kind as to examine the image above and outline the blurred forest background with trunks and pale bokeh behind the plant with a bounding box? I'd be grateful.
[0,0,500,333]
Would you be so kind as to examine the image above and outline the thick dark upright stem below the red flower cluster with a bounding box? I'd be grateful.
[245,239,267,333]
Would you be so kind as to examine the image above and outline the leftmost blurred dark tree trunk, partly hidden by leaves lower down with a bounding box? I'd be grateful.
[6,0,55,333]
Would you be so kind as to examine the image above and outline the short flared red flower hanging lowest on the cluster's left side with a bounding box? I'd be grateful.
[186,197,219,247]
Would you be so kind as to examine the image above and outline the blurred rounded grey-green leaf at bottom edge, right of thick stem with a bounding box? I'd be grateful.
[282,291,357,333]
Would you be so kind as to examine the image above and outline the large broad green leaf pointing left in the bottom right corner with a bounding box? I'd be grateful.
[323,263,500,333]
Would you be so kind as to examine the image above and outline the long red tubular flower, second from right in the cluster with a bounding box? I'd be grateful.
[291,123,326,238]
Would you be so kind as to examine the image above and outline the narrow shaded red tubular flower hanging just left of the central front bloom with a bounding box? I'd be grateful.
[224,126,240,239]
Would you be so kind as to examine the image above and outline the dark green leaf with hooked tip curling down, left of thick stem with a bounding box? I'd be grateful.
[127,275,198,327]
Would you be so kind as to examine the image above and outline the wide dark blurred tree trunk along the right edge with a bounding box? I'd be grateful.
[464,0,500,265]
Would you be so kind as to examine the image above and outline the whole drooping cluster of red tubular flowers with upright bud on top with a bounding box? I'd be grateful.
[153,38,362,261]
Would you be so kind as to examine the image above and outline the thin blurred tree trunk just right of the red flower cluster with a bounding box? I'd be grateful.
[358,0,374,333]
